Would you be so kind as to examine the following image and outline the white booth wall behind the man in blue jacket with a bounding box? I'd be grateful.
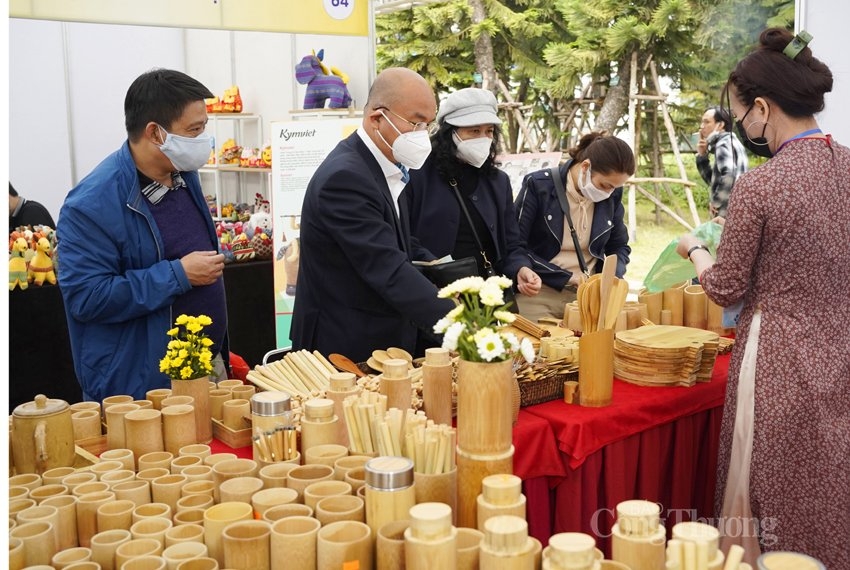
[9,18,372,219]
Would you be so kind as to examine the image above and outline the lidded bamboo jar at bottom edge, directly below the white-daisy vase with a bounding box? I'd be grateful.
[480,515,535,570]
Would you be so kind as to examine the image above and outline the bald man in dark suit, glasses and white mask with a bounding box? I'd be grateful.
[290,68,454,362]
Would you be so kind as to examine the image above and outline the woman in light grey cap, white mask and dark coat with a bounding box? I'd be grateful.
[402,87,541,304]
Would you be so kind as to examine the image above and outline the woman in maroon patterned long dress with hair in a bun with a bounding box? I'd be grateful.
[677,28,850,568]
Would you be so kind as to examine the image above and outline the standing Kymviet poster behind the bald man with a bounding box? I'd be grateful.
[271,118,362,347]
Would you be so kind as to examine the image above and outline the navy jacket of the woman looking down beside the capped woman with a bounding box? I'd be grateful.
[514,160,632,291]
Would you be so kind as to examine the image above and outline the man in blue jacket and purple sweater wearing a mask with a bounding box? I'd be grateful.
[57,69,227,400]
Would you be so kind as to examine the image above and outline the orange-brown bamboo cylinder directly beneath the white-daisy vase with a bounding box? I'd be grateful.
[457,446,514,528]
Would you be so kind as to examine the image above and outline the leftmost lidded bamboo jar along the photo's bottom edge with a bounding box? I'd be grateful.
[404,503,457,570]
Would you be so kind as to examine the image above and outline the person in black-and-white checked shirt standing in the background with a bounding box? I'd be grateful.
[696,107,747,217]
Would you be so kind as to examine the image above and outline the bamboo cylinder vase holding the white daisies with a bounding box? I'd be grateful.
[457,360,510,452]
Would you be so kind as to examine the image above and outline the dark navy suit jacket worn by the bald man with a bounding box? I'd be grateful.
[290,132,454,362]
